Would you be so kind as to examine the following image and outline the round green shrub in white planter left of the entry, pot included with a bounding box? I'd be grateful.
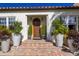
[10,21,22,47]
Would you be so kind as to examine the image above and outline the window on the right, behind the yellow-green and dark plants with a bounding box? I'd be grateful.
[61,16,76,30]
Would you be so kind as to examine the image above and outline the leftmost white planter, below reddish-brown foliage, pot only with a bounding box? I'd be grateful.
[1,38,10,52]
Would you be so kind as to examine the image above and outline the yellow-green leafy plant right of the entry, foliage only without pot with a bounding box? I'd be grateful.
[53,19,68,35]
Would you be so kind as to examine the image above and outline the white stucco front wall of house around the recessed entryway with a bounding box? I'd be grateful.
[0,10,79,41]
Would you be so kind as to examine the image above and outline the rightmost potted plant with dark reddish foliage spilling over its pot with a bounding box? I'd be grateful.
[68,30,79,53]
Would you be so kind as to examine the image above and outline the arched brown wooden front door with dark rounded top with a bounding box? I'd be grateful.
[32,18,41,39]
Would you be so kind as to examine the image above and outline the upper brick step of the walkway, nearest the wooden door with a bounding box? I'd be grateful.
[20,40,53,49]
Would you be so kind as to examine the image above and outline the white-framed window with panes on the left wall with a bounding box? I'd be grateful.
[0,17,15,27]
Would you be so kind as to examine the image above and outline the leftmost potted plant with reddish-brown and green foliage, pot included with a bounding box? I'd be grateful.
[0,26,11,52]
